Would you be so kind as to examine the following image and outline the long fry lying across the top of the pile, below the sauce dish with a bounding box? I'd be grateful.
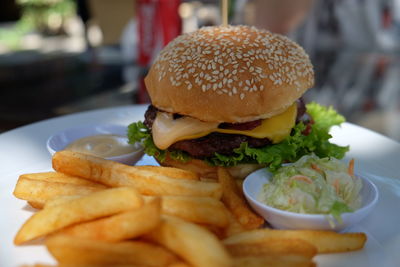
[53,150,222,199]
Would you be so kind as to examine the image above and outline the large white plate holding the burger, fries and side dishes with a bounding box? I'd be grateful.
[0,106,400,267]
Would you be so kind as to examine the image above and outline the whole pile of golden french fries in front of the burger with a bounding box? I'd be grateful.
[14,151,366,267]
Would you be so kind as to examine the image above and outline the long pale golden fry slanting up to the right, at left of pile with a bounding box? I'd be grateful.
[14,187,143,245]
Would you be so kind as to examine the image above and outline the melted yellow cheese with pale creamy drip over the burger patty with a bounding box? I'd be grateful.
[152,103,297,149]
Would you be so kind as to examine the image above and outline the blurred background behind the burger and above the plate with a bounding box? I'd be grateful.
[0,0,400,141]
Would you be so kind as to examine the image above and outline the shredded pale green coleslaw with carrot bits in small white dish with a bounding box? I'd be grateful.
[258,154,362,224]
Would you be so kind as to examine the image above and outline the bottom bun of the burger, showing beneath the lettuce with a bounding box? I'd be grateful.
[159,156,264,179]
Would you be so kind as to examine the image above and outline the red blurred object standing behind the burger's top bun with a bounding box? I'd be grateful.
[137,0,182,103]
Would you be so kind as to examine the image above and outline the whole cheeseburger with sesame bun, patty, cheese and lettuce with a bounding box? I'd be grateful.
[128,26,348,178]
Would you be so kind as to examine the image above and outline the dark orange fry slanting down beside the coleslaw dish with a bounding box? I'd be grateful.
[218,167,264,230]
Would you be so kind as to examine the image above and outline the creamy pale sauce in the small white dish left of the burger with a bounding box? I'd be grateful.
[65,134,137,158]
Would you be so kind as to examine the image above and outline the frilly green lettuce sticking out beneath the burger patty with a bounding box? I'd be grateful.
[128,102,349,171]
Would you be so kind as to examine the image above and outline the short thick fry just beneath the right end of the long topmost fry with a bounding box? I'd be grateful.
[146,196,229,227]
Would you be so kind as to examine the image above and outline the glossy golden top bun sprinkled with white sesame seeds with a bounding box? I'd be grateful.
[145,26,314,123]
